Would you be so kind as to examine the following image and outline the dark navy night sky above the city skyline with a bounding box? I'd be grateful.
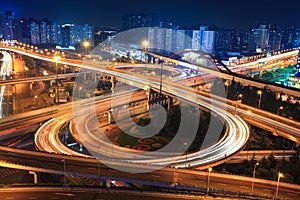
[0,0,300,29]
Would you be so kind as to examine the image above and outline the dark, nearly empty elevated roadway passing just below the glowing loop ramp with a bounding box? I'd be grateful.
[0,147,300,199]
